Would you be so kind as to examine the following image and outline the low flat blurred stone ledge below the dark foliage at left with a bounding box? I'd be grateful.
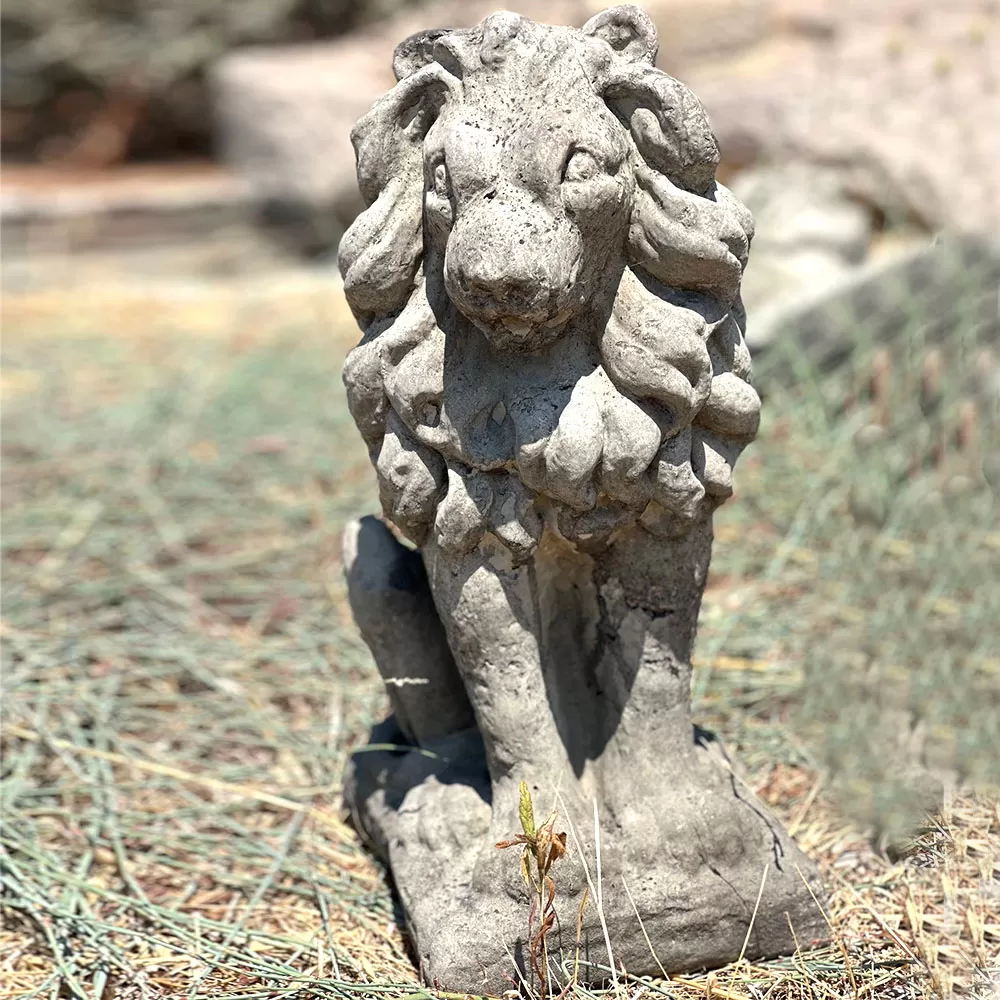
[0,162,330,292]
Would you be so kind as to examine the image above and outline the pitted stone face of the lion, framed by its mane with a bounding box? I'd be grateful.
[423,88,634,351]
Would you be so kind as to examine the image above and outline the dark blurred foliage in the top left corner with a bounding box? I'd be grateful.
[0,0,402,166]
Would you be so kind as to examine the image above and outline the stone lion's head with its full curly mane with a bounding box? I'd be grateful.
[340,7,760,558]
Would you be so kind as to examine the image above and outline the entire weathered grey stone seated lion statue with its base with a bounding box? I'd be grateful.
[340,7,826,993]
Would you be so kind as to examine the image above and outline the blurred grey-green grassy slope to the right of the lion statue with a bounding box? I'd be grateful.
[695,238,1000,840]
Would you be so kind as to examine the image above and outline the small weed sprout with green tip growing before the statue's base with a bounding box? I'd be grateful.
[496,781,566,997]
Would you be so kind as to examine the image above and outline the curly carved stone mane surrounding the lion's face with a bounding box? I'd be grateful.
[340,7,760,560]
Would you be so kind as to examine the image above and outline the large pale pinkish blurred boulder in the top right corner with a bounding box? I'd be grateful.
[681,0,1000,231]
